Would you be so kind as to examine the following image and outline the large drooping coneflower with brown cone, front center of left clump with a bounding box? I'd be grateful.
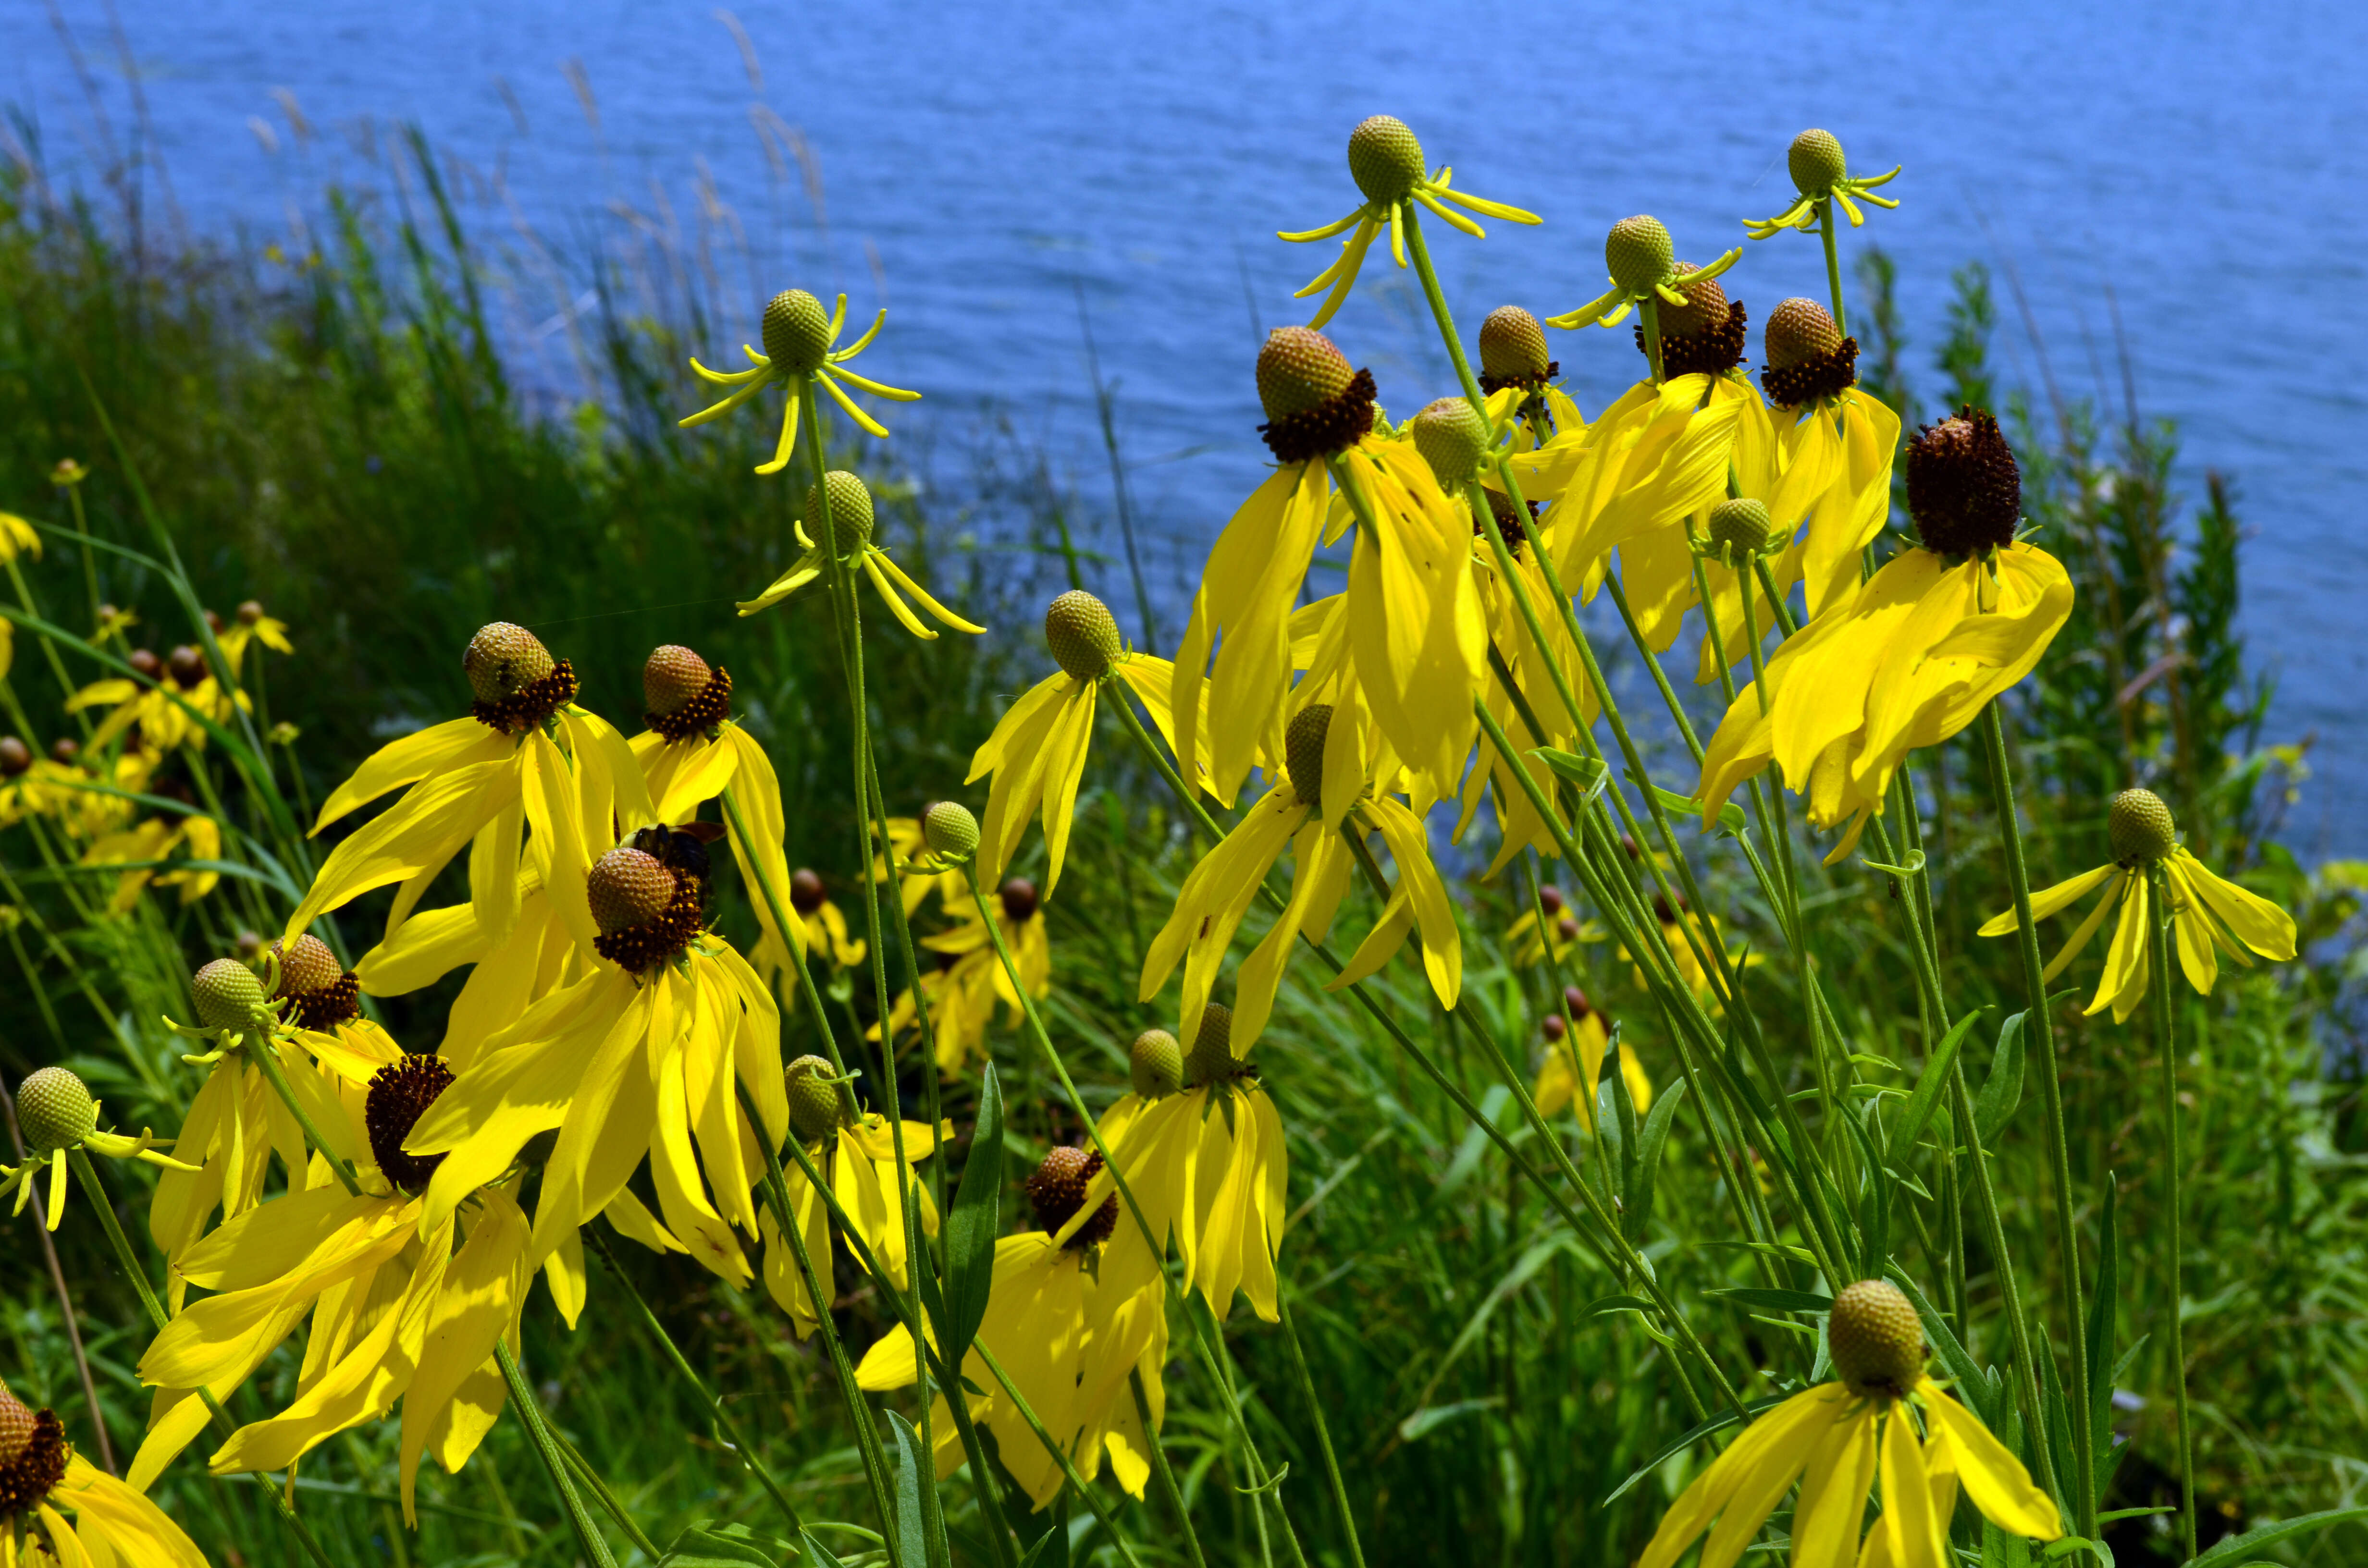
[407,827,789,1324]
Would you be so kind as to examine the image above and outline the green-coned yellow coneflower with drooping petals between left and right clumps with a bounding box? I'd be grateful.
[964,588,1203,898]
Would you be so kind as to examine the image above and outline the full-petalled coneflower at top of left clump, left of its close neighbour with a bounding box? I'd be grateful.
[284,621,654,945]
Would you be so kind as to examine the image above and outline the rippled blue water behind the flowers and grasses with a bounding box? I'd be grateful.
[13,0,2368,855]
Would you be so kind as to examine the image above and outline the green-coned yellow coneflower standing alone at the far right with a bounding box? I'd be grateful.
[1980,789,2294,1023]
